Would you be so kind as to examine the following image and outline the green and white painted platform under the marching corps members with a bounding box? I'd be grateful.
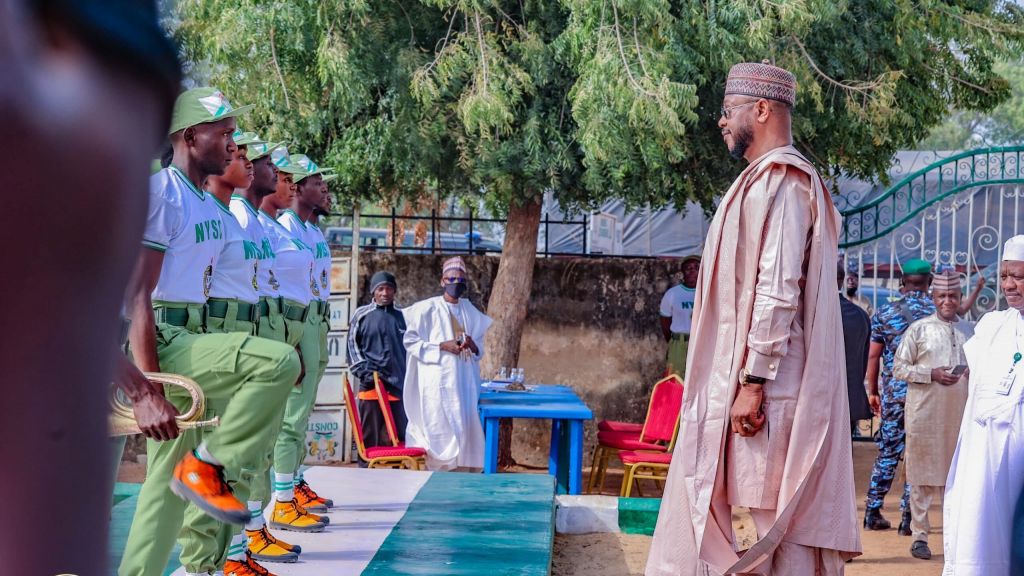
[112,466,555,576]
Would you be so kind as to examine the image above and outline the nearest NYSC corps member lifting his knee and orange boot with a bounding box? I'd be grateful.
[119,88,300,576]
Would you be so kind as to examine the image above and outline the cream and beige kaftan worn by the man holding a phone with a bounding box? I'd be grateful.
[893,315,974,486]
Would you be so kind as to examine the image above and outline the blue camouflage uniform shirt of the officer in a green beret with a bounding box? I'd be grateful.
[871,291,935,404]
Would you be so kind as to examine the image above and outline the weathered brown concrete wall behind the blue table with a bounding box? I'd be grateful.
[348,252,679,466]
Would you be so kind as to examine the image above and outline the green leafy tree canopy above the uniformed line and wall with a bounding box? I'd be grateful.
[173,0,1024,212]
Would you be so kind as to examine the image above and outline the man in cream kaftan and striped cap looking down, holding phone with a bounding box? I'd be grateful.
[893,271,974,560]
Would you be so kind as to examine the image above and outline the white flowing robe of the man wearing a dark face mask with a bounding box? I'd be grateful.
[402,296,492,470]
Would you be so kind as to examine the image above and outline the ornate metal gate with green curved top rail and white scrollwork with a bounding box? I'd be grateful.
[838,146,1024,320]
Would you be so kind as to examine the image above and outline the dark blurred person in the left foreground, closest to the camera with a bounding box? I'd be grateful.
[0,0,180,574]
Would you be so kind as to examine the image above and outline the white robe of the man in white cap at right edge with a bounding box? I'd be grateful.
[942,310,1024,576]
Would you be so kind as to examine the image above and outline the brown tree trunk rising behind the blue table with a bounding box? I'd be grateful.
[482,195,541,468]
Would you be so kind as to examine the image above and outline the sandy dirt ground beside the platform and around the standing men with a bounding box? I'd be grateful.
[551,436,942,576]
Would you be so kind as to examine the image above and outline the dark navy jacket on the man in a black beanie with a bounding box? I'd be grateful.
[347,302,406,393]
